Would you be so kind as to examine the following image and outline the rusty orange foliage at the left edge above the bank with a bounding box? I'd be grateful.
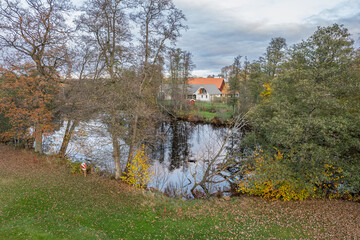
[0,64,57,141]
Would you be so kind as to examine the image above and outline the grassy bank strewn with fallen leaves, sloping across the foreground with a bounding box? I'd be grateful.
[0,145,360,239]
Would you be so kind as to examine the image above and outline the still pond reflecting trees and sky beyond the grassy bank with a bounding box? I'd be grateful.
[44,121,240,195]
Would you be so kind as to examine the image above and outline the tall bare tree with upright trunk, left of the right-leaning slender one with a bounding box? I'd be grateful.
[77,0,132,179]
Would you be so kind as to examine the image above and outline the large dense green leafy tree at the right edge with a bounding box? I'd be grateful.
[243,24,360,195]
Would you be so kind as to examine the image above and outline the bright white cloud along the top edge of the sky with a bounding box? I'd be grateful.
[174,0,345,24]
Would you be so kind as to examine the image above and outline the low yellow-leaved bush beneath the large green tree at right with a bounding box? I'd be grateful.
[238,150,342,201]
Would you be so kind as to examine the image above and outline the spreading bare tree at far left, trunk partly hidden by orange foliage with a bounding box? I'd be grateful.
[0,0,71,152]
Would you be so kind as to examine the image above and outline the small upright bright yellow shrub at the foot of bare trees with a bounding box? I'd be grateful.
[121,145,154,188]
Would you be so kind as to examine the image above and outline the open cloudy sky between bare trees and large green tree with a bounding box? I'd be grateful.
[170,0,360,77]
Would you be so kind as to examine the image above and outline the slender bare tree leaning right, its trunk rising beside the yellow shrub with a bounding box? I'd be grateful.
[125,0,186,173]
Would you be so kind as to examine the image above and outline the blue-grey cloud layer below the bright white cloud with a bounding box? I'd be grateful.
[173,0,360,74]
